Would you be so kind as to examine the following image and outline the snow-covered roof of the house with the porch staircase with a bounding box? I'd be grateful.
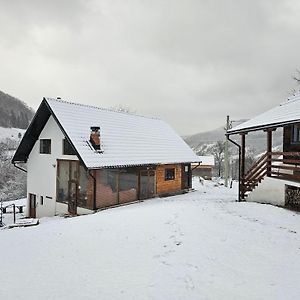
[228,93,300,134]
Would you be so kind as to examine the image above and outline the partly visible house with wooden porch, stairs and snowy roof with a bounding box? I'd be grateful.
[227,94,300,209]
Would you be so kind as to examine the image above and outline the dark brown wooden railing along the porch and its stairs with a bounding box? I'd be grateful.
[240,152,300,199]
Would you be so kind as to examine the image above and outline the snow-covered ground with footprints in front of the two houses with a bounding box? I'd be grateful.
[0,182,300,300]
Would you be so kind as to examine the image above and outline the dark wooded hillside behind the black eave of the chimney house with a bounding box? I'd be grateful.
[0,91,34,129]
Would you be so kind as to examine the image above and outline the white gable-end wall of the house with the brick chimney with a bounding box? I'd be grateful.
[26,116,78,218]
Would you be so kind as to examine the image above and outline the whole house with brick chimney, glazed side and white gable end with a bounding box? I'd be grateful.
[12,98,199,217]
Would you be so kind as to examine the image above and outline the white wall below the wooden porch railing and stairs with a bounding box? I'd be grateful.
[247,177,300,206]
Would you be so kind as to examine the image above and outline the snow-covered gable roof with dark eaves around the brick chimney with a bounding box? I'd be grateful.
[13,98,200,169]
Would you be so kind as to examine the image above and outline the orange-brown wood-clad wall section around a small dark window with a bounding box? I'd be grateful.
[156,164,181,194]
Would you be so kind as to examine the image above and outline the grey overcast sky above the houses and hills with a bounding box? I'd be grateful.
[0,0,300,135]
